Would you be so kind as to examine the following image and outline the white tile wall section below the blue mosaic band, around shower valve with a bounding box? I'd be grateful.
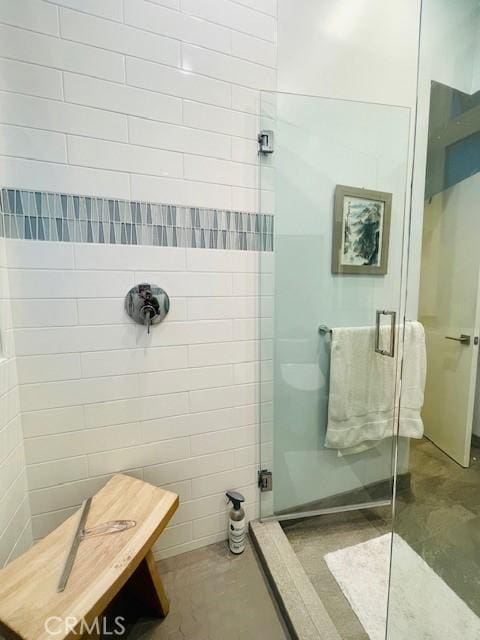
[6,240,273,556]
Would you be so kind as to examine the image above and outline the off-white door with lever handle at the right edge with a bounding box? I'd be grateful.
[419,174,480,467]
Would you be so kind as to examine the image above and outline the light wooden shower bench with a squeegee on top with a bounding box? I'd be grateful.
[0,474,178,640]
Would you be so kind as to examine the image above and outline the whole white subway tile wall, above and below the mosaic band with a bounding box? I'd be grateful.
[0,0,276,555]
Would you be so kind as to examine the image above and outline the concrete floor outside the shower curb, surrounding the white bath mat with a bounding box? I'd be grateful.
[283,440,480,640]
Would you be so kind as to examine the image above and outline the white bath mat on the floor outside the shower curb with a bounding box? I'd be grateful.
[325,534,480,640]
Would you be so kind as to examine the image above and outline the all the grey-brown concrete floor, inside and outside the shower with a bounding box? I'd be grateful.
[119,440,480,640]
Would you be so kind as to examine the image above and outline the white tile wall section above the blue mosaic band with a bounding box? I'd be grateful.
[0,0,276,212]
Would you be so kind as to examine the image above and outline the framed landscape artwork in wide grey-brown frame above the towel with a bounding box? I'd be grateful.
[332,185,392,275]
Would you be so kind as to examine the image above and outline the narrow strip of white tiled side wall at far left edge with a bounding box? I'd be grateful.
[0,238,32,567]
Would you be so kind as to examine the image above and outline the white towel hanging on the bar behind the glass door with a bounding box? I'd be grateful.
[325,322,426,453]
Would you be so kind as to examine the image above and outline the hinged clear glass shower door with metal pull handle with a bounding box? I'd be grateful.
[259,93,410,518]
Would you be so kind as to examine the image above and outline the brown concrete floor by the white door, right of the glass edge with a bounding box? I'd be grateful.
[392,440,480,616]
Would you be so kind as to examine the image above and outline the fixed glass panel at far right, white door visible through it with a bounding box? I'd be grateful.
[387,0,480,640]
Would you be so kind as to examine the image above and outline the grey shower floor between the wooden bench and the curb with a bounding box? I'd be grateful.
[125,543,290,640]
